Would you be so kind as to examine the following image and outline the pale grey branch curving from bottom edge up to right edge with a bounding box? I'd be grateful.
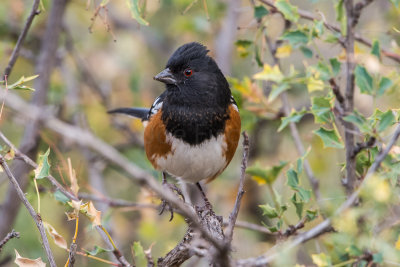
[237,124,400,266]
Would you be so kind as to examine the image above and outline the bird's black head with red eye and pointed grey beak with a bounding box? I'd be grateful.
[154,42,231,108]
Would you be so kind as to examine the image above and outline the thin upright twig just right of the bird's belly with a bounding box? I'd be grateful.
[225,132,249,245]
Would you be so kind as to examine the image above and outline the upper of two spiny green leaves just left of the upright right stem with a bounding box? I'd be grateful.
[311,96,335,123]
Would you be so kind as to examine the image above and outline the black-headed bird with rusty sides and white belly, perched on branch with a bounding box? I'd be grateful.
[108,42,241,220]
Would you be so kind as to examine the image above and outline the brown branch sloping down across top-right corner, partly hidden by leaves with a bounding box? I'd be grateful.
[259,0,400,63]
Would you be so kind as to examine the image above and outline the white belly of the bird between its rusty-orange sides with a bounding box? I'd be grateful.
[156,134,227,183]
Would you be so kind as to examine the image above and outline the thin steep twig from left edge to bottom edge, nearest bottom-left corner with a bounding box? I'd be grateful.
[0,155,57,267]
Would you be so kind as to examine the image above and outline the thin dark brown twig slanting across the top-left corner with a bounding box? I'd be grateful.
[3,0,40,80]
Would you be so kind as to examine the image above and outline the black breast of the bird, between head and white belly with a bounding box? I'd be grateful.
[161,105,229,145]
